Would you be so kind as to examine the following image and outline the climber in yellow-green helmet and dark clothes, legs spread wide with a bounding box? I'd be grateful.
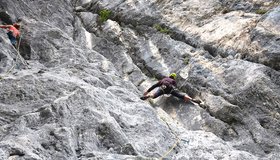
[140,73,201,104]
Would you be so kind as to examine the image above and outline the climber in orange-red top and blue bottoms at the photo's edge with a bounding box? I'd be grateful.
[0,19,21,48]
